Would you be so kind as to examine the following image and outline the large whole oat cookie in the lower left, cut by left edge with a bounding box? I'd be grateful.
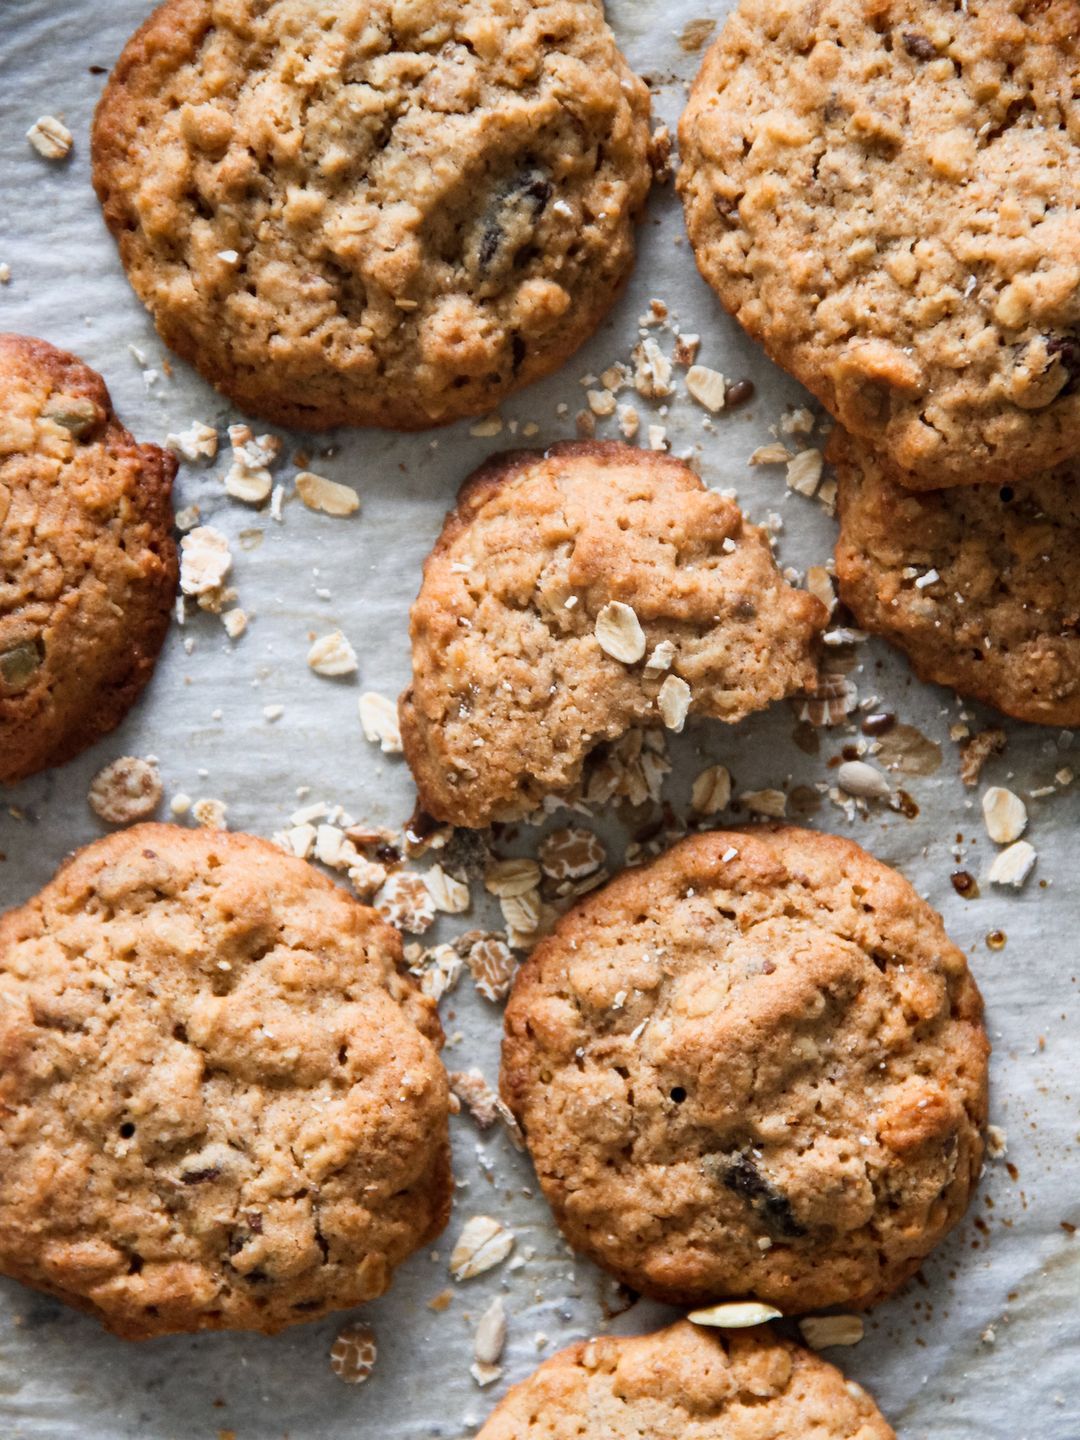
[0,825,452,1339]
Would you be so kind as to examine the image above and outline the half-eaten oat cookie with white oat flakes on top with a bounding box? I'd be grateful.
[400,442,827,827]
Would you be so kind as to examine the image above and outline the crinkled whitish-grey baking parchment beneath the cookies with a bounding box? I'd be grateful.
[0,0,1080,1440]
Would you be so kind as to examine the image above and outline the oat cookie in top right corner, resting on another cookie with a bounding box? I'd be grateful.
[678,0,1080,488]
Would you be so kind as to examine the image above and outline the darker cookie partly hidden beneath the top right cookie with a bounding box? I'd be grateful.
[829,431,1080,726]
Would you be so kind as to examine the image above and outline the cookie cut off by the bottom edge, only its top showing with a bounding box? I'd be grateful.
[478,1320,896,1440]
